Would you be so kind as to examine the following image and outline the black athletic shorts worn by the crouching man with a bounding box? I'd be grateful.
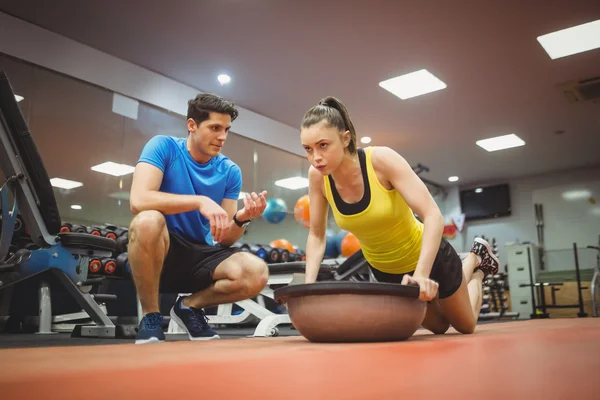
[160,232,240,293]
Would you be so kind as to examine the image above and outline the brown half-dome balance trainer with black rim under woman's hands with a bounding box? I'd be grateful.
[274,282,427,343]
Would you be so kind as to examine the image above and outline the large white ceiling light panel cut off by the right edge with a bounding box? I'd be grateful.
[537,19,600,60]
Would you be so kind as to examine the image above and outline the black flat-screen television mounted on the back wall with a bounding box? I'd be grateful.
[460,184,511,221]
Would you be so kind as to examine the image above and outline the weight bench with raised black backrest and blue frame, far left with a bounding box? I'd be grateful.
[0,71,116,337]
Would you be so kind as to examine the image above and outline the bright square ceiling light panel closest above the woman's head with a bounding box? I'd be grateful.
[379,69,447,100]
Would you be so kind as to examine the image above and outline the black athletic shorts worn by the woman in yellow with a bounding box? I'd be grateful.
[344,238,463,299]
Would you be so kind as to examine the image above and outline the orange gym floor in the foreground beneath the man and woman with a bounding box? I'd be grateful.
[0,318,600,400]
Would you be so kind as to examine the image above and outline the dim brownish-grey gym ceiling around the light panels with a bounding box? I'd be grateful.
[0,0,600,186]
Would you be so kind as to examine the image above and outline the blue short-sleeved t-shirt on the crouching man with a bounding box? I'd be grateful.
[138,135,242,246]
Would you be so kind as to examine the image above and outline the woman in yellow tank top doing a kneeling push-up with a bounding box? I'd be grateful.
[301,97,499,333]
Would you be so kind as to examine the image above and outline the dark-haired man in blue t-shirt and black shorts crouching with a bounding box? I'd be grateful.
[128,93,268,344]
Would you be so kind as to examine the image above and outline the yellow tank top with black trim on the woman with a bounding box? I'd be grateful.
[324,147,423,274]
